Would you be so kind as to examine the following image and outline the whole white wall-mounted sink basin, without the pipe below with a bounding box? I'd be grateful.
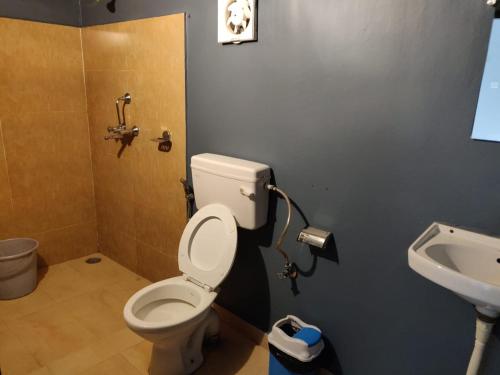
[408,223,500,318]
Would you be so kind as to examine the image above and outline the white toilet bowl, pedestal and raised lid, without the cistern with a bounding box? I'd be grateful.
[123,204,237,375]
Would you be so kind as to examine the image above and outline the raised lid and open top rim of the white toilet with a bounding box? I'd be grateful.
[124,204,237,333]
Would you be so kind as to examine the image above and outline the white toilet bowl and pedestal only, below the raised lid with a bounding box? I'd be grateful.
[124,277,219,375]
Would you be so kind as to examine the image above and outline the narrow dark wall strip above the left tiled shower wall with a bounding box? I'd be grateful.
[0,0,80,25]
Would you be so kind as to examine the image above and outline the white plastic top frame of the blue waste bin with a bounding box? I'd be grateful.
[267,315,325,362]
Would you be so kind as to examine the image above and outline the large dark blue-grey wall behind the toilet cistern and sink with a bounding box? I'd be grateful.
[5,0,500,375]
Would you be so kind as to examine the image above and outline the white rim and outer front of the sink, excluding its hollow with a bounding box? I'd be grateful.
[408,222,500,315]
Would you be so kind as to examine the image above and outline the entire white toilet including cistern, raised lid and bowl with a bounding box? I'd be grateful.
[123,154,270,375]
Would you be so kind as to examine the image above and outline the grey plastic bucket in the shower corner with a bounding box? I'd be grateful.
[0,238,38,300]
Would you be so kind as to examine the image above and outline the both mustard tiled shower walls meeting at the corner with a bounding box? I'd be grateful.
[0,14,186,280]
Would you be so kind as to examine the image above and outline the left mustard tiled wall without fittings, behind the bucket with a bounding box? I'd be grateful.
[0,18,96,264]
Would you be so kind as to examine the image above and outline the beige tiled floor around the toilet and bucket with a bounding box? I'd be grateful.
[0,254,268,375]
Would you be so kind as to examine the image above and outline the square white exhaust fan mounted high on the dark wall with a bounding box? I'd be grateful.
[218,0,257,44]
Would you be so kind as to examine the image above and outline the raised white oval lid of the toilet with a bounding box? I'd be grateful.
[179,204,238,289]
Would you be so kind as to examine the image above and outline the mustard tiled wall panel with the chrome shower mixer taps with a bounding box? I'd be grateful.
[83,14,186,280]
